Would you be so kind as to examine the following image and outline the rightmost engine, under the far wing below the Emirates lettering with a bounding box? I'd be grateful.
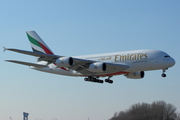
[124,71,145,79]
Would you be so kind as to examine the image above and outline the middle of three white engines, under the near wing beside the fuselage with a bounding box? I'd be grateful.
[88,62,106,72]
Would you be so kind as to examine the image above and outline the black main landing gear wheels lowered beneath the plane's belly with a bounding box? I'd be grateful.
[84,76,113,84]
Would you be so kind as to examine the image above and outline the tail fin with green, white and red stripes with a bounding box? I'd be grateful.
[26,31,54,55]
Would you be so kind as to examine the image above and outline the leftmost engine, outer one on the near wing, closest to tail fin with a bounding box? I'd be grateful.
[55,57,73,67]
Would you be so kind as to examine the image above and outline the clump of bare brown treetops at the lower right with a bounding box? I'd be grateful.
[110,101,180,120]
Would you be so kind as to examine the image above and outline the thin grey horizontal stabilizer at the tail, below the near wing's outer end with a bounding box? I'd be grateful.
[5,60,47,67]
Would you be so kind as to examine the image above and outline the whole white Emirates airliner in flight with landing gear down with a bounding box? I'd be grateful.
[4,31,175,83]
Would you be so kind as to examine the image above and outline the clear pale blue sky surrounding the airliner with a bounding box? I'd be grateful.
[0,0,180,120]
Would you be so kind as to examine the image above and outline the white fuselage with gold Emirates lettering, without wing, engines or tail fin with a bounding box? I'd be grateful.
[30,50,175,77]
